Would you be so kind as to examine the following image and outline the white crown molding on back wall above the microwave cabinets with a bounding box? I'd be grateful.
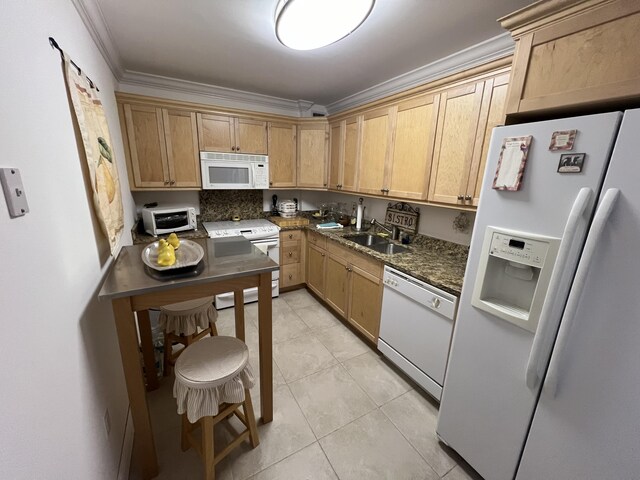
[120,70,325,117]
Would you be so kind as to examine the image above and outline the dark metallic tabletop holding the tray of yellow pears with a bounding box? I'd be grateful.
[98,237,278,299]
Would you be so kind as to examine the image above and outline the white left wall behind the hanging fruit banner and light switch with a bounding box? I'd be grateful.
[0,0,135,479]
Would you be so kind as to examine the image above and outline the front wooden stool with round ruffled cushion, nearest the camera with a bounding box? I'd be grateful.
[173,336,260,480]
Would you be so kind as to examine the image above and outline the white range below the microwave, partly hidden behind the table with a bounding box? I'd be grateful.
[202,220,280,310]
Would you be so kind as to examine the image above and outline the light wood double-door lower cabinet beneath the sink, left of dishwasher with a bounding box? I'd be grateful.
[307,231,383,343]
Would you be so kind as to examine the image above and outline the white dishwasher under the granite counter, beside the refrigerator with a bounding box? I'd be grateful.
[378,266,458,401]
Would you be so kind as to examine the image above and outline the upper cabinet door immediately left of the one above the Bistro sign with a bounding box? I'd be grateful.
[358,108,391,195]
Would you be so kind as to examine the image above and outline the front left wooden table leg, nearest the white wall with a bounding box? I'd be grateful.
[112,297,158,479]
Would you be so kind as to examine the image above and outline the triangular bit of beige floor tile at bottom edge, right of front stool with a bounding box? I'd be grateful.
[246,442,338,480]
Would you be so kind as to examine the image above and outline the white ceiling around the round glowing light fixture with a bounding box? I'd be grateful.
[95,0,532,105]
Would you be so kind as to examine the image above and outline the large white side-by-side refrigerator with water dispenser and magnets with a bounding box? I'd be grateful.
[437,110,640,480]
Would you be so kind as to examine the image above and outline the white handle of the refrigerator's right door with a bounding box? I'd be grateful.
[544,188,620,397]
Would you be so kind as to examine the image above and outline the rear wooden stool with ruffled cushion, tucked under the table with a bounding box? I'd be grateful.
[159,297,218,377]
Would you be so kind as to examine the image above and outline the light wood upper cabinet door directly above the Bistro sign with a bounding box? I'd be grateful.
[389,95,440,200]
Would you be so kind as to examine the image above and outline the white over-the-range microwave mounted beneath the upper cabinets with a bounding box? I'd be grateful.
[200,152,269,190]
